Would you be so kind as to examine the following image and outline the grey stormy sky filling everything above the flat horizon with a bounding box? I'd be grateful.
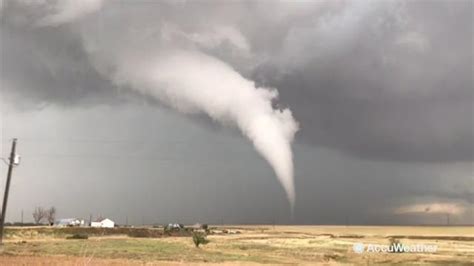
[0,0,474,224]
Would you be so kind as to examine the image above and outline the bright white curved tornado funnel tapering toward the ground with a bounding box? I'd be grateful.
[113,51,298,210]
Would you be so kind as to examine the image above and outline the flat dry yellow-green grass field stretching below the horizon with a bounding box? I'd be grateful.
[0,226,474,265]
